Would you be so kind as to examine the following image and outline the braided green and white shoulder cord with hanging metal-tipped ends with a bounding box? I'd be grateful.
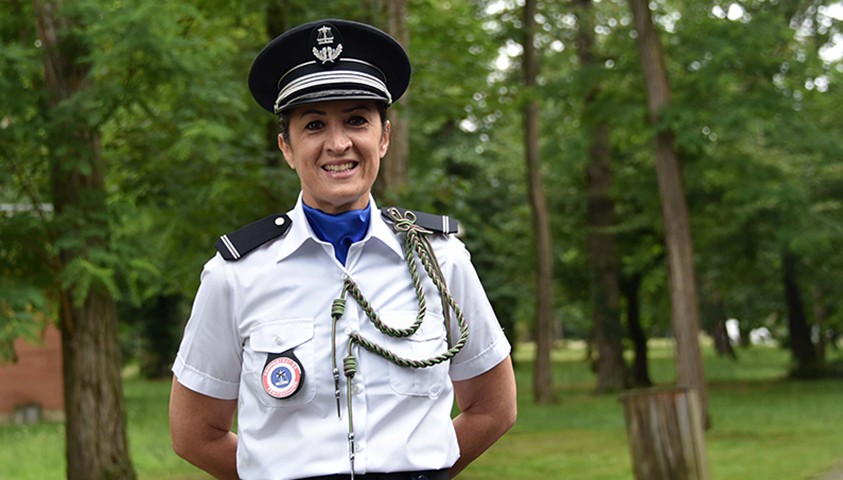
[331,208,468,480]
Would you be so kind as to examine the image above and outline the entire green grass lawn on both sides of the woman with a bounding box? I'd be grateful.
[0,342,843,480]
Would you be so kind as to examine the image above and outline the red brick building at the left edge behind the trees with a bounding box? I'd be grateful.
[0,325,64,423]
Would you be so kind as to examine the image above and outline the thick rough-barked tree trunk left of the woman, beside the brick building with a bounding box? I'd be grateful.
[35,0,135,480]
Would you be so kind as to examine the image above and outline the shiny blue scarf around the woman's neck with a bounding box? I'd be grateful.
[302,203,372,265]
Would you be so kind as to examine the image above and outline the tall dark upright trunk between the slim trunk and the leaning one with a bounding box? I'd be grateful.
[574,0,628,392]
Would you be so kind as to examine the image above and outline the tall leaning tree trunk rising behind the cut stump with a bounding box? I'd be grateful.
[629,0,710,428]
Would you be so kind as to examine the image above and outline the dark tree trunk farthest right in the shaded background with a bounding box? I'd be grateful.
[782,249,823,378]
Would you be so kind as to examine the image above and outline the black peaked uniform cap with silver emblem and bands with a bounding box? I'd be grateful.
[249,19,411,114]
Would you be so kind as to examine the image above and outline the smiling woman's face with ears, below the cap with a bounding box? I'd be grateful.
[278,100,389,214]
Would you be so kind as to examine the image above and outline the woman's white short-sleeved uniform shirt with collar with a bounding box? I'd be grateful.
[173,198,510,480]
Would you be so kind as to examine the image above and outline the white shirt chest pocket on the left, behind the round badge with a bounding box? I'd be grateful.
[243,318,319,408]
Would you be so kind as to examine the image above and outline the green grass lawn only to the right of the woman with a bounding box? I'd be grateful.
[460,345,843,480]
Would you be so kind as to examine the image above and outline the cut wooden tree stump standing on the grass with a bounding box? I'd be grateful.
[620,387,709,480]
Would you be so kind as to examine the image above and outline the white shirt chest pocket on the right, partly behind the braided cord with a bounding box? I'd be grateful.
[381,312,449,398]
